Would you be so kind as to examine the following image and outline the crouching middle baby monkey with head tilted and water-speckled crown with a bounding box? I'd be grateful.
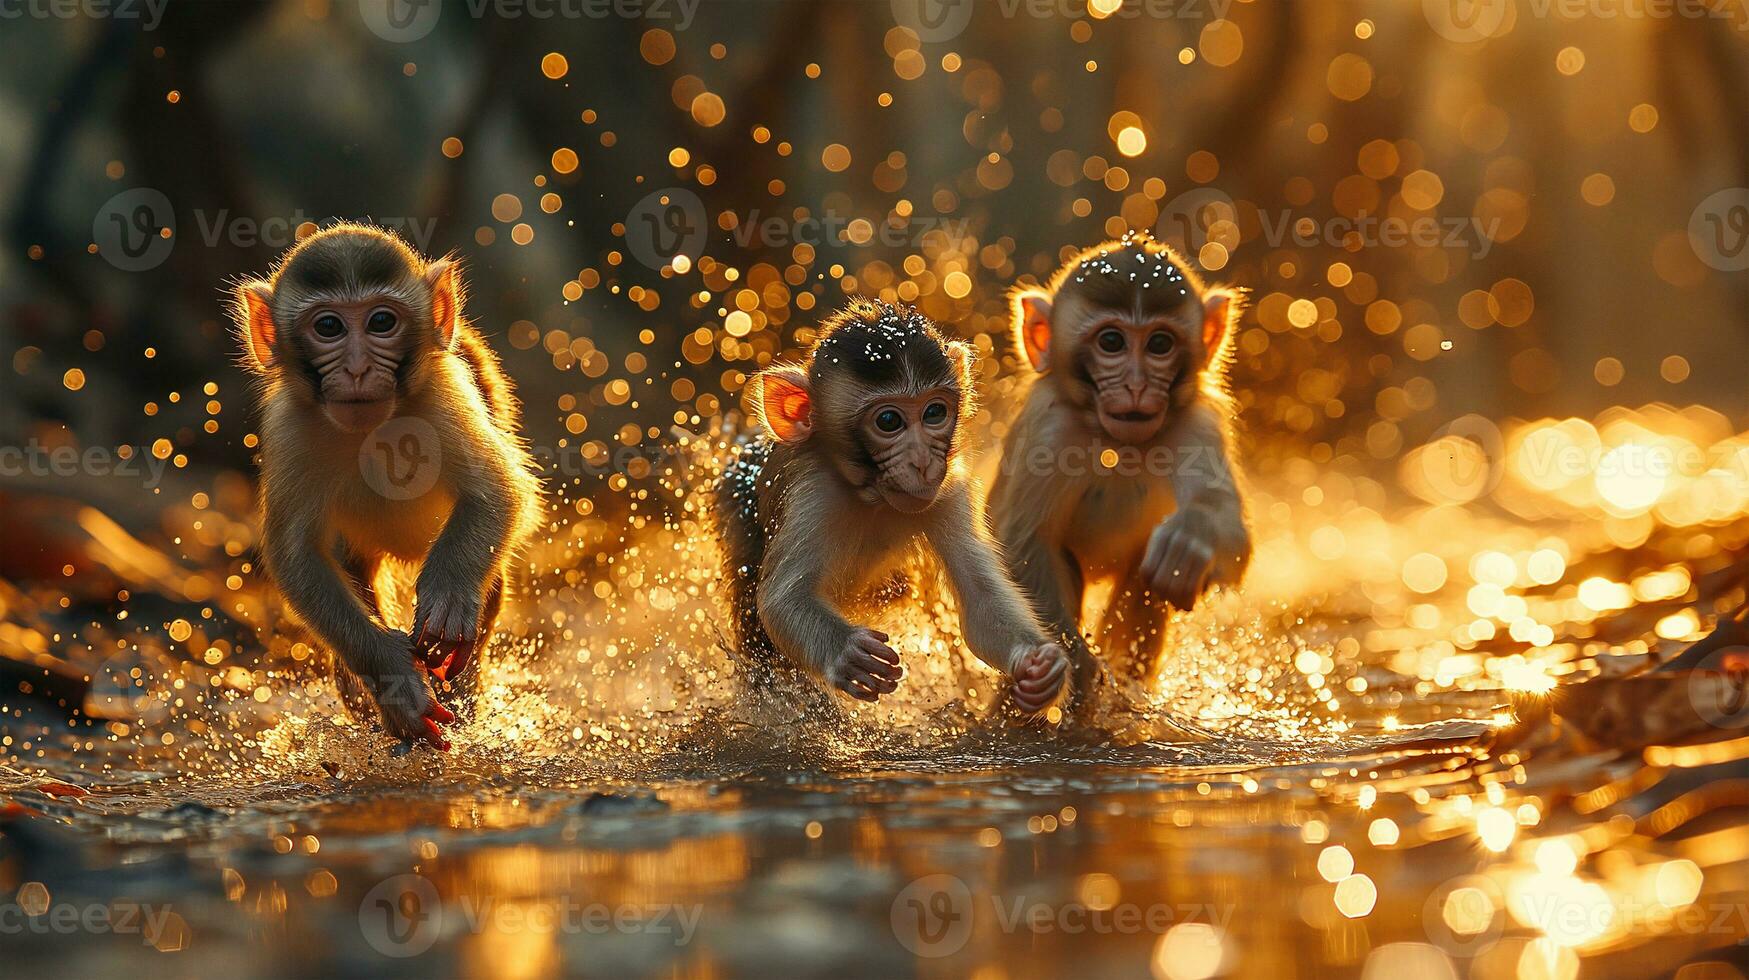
[715,299,1069,714]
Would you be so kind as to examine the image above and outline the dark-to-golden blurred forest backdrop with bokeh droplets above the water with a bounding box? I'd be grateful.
[0,0,1749,518]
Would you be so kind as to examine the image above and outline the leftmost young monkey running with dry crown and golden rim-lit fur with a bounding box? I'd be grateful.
[233,222,539,749]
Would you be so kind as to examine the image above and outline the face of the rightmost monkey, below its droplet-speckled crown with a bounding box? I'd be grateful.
[1076,312,1189,446]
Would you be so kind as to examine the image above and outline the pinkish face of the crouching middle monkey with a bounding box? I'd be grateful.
[855,387,960,515]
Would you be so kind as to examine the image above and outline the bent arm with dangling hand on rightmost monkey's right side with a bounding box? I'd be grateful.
[1142,401,1251,609]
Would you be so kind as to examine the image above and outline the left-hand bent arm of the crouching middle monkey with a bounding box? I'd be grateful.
[757,474,901,702]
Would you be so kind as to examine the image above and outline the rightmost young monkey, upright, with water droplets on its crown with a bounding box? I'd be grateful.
[990,238,1251,679]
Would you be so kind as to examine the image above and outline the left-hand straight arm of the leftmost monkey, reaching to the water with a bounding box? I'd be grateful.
[264,486,453,747]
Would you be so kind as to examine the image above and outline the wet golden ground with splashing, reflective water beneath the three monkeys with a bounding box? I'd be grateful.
[0,406,1749,980]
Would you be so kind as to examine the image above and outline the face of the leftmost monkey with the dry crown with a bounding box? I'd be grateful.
[297,298,413,432]
